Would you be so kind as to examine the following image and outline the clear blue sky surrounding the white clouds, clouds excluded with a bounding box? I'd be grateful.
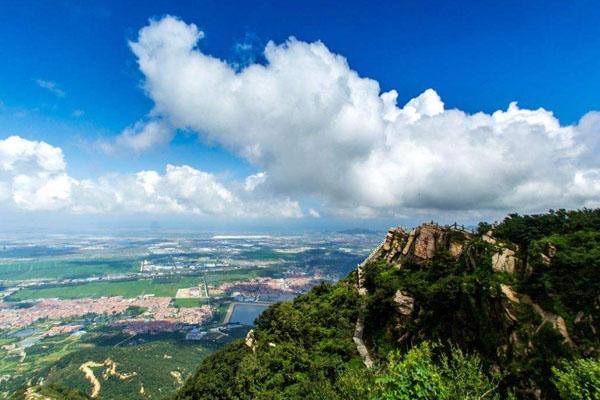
[0,1,600,230]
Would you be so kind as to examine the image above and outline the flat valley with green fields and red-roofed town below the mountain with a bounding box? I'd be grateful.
[0,233,378,399]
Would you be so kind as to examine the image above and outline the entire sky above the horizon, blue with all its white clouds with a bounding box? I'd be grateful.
[0,0,600,230]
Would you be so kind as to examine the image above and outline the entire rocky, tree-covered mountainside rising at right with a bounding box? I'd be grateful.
[174,210,600,400]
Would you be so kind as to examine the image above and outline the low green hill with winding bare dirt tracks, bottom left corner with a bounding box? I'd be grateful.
[0,327,222,400]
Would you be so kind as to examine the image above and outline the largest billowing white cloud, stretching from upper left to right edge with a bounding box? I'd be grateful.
[130,16,600,217]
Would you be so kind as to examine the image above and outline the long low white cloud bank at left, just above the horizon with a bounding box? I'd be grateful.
[0,136,303,218]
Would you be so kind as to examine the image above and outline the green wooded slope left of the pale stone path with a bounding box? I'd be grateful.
[177,281,364,400]
